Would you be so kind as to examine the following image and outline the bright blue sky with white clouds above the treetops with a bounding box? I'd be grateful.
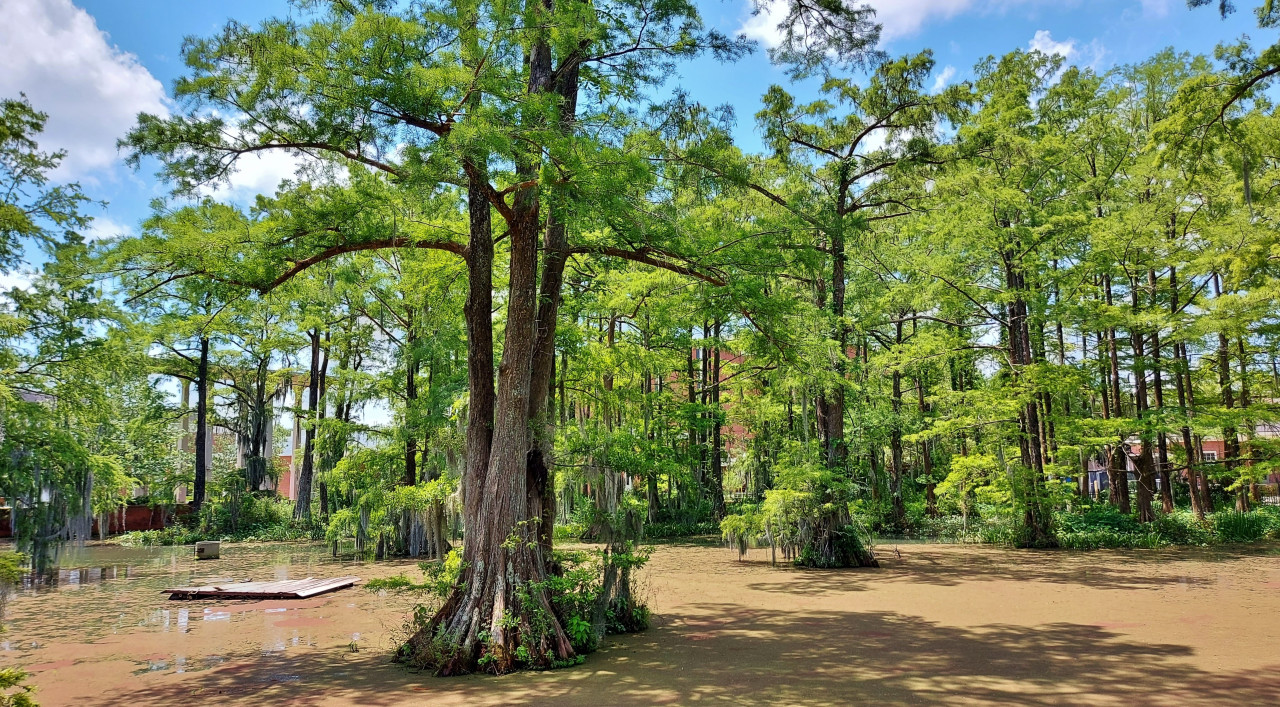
[0,0,1259,288]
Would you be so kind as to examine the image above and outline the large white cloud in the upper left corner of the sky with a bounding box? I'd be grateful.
[0,0,168,178]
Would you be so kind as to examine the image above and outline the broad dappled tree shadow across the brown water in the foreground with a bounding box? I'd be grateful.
[112,603,1280,706]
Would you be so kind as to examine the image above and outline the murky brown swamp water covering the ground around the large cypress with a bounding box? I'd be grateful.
[0,543,1280,707]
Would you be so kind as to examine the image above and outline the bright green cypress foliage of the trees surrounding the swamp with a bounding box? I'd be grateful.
[17,0,1280,672]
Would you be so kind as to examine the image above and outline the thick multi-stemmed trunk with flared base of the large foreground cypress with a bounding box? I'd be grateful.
[404,24,573,675]
